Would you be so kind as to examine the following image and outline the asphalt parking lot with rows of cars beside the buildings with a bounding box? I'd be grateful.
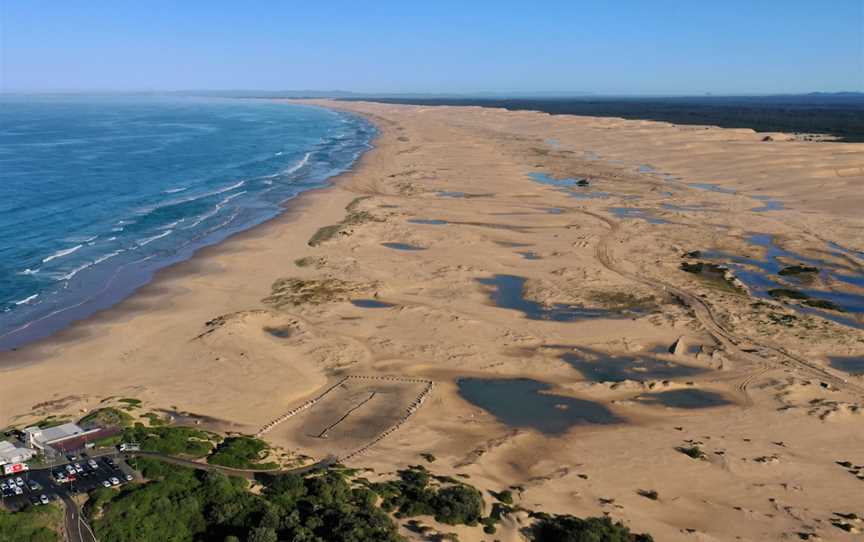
[0,456,136,510]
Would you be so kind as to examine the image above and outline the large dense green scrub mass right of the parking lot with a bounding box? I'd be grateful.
[85,458,402,542]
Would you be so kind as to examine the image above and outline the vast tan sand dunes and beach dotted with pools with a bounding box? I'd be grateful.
[0,101,864,541]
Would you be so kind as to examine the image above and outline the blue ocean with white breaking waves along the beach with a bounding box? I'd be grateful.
[0,95,376,350]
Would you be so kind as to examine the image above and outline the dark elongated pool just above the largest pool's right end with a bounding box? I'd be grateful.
[561,350,707,382]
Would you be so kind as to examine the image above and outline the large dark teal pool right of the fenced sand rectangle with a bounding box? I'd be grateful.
[457,378,624,435]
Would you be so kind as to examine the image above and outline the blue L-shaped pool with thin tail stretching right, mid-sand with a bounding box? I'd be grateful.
[477,275,625,322]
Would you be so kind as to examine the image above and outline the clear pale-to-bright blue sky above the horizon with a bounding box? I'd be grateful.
[0,0,864,94]
